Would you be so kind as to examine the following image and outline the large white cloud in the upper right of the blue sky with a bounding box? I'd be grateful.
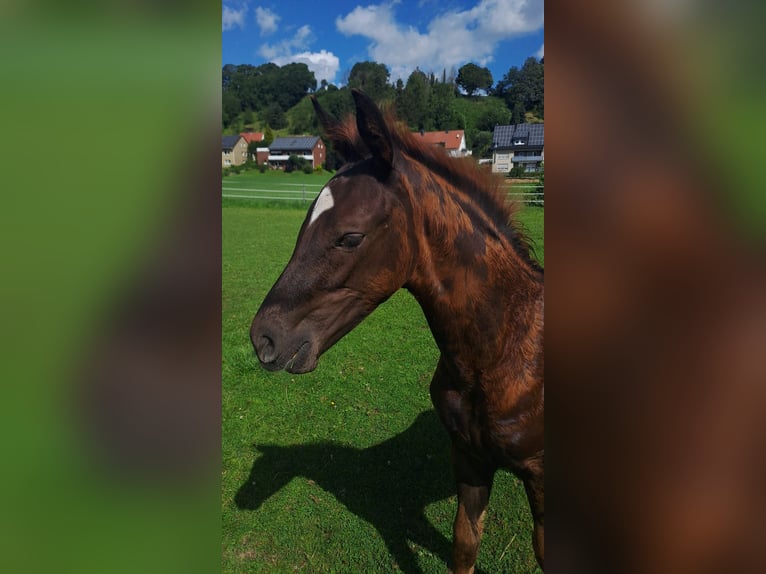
[335,0,544,79]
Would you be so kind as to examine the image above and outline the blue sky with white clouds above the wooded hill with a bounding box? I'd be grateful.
[222,0,544,85]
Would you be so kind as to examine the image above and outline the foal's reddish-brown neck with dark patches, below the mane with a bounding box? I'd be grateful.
[405,187,543,378]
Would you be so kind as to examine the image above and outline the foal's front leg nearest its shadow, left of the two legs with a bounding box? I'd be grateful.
[452,448,494,574]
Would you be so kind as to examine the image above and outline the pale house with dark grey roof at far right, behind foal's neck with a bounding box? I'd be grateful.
[492,123,545,173]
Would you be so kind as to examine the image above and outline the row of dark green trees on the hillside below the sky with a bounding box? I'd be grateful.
[222,57,545,157]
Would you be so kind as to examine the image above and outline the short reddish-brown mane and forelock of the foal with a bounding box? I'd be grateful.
[327,108,543,272]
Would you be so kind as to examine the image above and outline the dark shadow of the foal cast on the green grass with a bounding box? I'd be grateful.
[234,410,474,573]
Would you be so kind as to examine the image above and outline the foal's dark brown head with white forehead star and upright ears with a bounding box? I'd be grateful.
[250,91,413,373]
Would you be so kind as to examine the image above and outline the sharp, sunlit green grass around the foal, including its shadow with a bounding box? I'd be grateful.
[221,196,543,573]
